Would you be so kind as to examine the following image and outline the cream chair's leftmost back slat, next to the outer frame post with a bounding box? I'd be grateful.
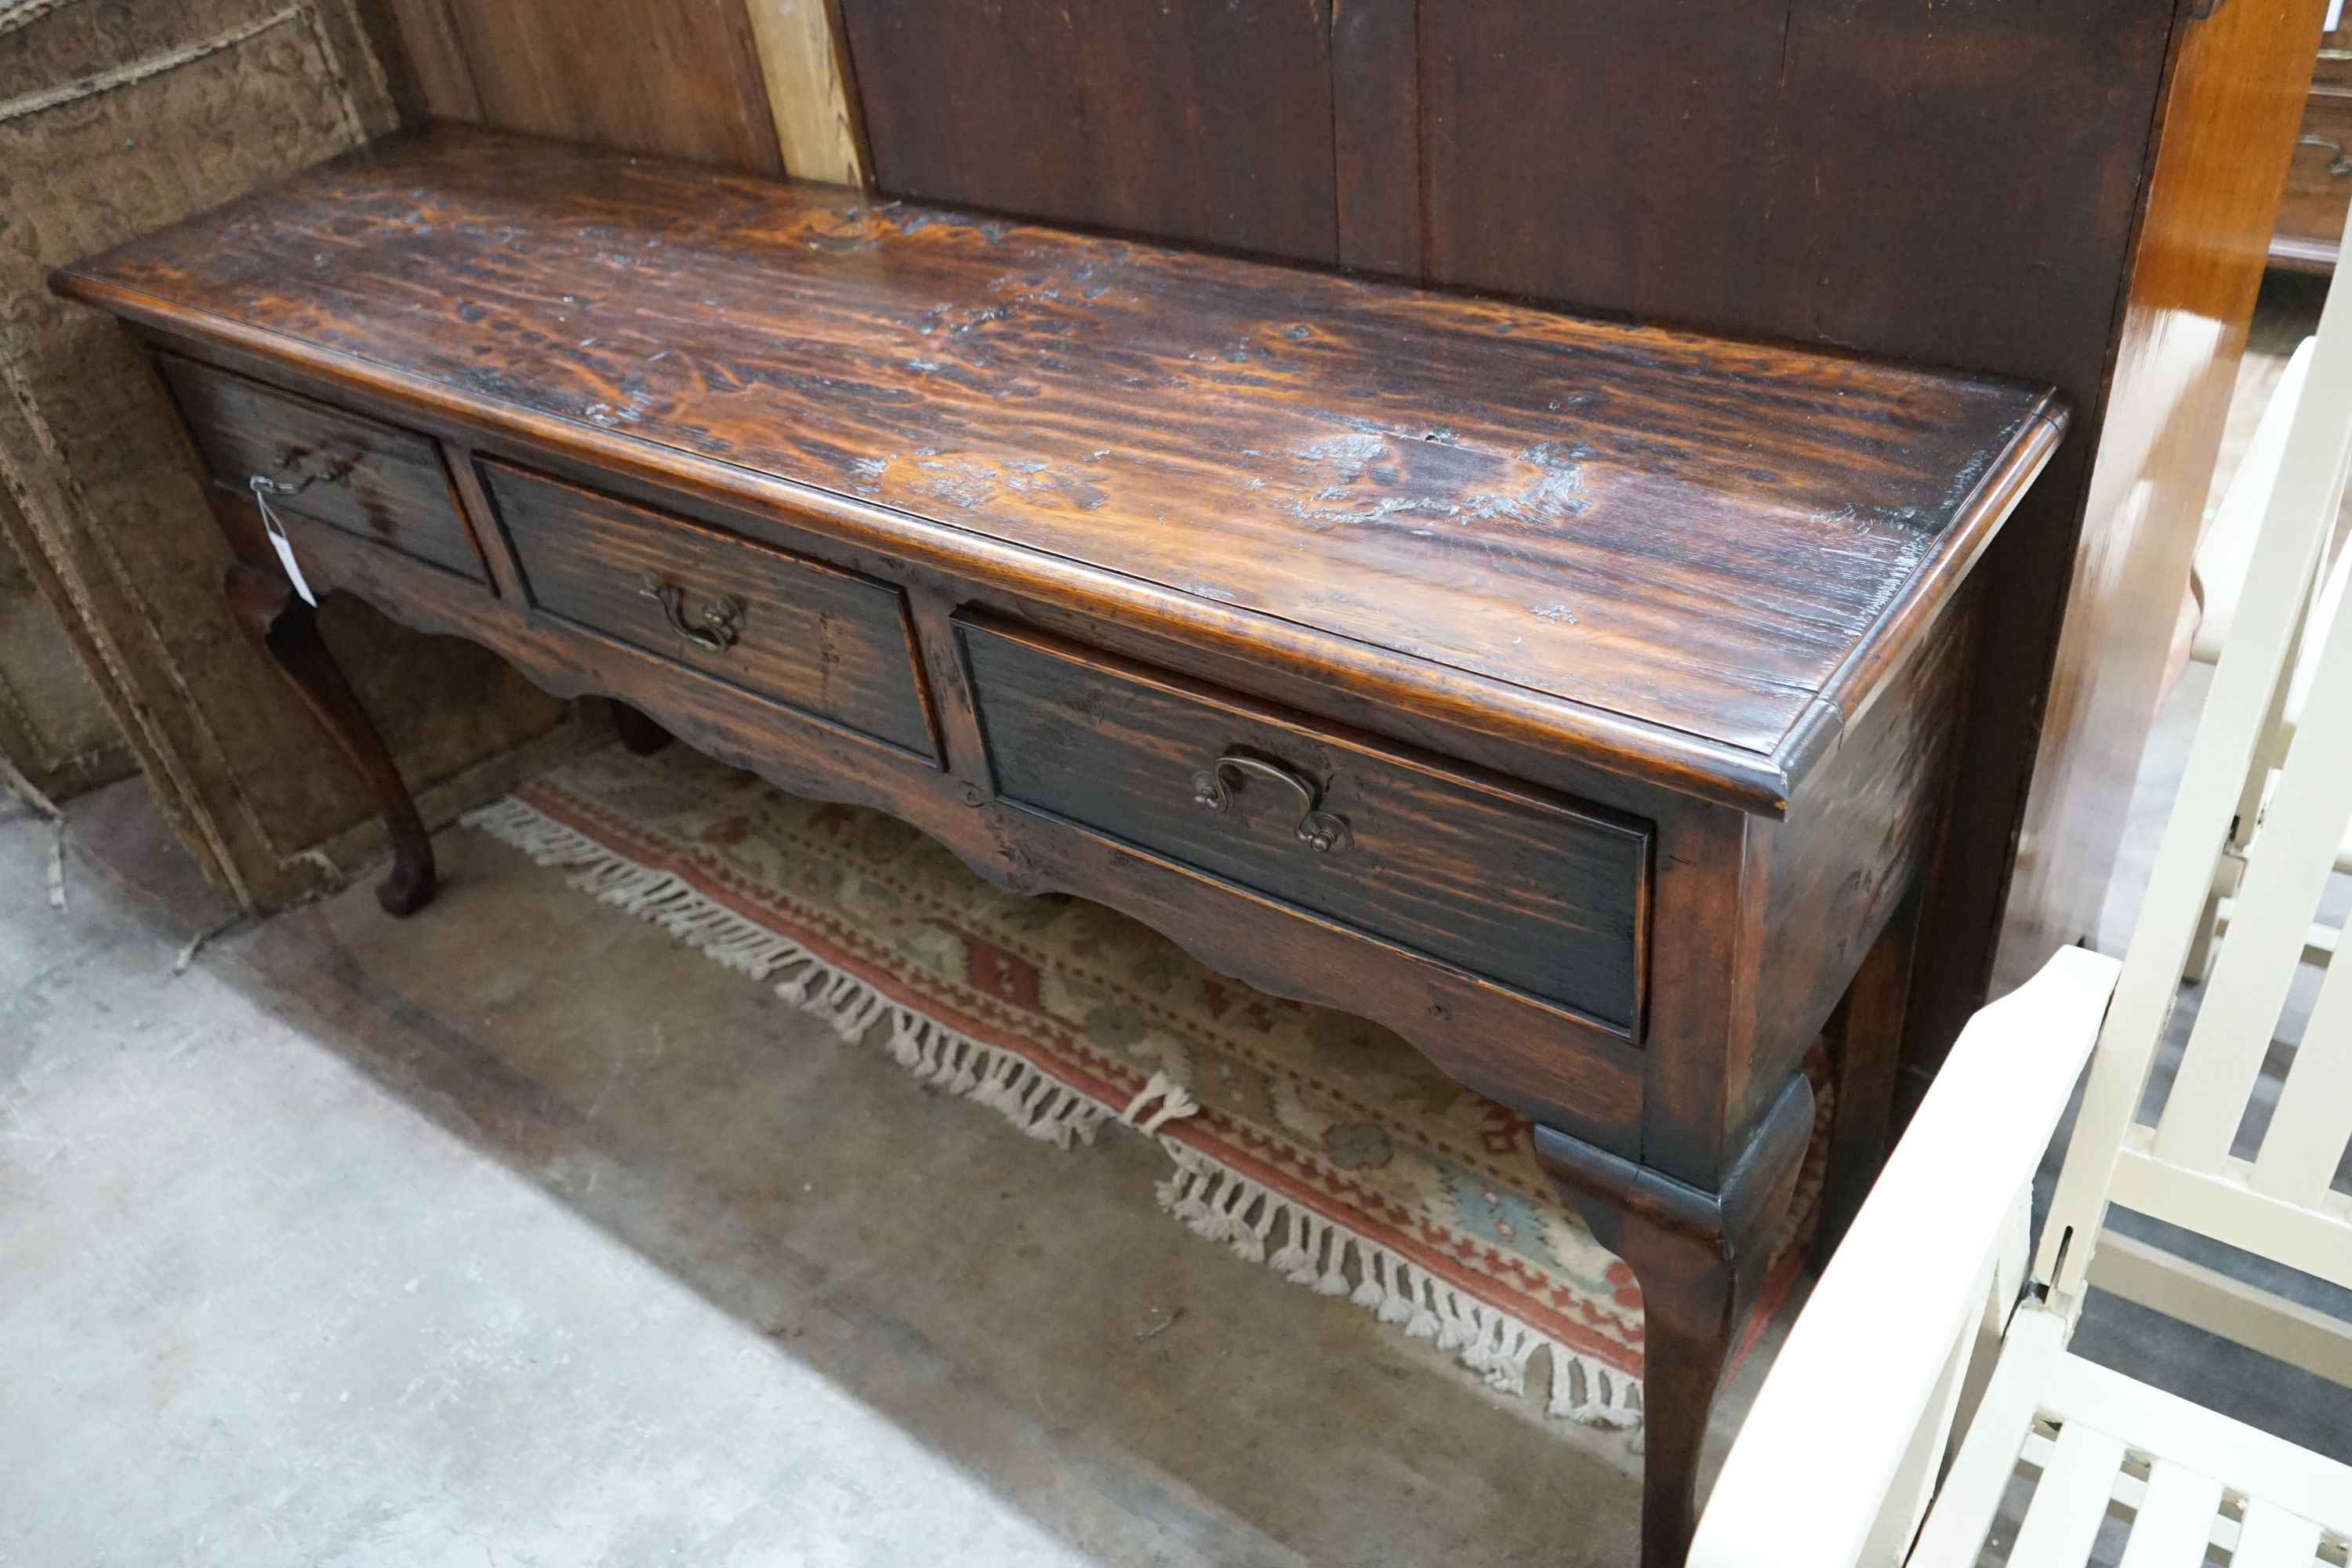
[2157,601,2352,1171]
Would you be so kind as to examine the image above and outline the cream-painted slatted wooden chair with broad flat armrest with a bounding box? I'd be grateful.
[1691,196,2352,1568]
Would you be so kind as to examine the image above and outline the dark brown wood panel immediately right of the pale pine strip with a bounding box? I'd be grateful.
[840,0,1338,261]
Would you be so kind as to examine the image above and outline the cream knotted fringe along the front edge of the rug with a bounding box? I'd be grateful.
[461,797,1642,1427]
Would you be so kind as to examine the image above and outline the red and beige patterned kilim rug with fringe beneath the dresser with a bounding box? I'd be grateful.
[466,746,1820,1427]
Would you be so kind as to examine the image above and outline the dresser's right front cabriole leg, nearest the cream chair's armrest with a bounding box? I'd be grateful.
[1536,1074,1813,1568]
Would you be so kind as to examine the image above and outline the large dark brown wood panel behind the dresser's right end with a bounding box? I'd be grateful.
[1421,0,2171,376]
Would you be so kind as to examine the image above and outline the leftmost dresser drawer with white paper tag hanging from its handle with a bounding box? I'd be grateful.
[155,353,489,583]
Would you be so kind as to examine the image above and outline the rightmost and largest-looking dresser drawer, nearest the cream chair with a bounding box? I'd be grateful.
[957,621,1649,1036]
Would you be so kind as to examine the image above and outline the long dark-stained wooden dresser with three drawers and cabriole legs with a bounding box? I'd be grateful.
[54,127,2065,1563]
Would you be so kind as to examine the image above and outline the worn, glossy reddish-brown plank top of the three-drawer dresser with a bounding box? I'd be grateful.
[54,127,2065,811]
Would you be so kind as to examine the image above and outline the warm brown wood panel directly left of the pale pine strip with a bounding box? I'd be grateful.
[369,0,783,174]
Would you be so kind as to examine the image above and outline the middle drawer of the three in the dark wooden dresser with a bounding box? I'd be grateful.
[482,461,938,762]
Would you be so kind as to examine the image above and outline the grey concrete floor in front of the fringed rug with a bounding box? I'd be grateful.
[0,783,1731,1568]
